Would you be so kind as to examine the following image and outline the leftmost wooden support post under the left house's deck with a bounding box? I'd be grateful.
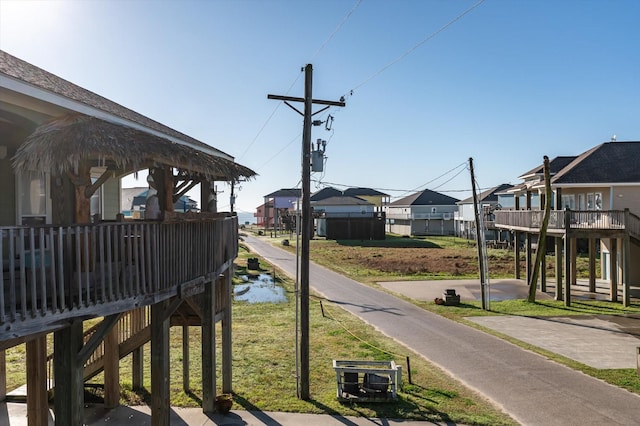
[26,335,49,426]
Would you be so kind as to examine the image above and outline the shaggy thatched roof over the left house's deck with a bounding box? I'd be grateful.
[12,114,255,223]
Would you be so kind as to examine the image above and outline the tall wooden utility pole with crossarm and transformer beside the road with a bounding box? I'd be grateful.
[267,64,345,400]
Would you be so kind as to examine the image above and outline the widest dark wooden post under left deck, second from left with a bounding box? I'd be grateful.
[53,321,84,426]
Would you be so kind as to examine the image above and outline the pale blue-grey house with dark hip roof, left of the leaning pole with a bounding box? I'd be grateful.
[384,189,459,235]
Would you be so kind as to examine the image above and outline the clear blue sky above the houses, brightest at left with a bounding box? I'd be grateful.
[0,0,640,218]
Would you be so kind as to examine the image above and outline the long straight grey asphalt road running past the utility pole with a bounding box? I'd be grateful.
[244,236,640,426]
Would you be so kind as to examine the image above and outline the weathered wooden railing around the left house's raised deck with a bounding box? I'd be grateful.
[0,217,238,341]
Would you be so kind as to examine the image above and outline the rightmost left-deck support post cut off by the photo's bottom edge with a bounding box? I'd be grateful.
[151,300,171,426]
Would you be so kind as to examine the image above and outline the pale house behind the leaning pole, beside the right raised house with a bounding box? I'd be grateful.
[454,183,513,240]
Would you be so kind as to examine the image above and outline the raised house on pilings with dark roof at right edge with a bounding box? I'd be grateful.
[495,141,640,306]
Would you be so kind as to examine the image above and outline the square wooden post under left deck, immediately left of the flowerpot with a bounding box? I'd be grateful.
[202,281,216,413]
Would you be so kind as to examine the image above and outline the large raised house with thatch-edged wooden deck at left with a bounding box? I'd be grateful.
[0,51,254,426]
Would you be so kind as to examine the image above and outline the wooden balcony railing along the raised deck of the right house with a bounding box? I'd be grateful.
[495,210,640,238]
